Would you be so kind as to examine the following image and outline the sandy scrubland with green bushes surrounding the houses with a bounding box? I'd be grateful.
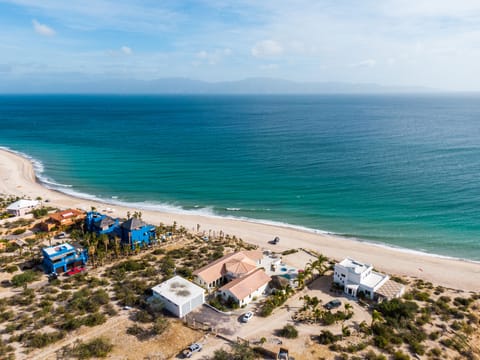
[0,194,480,359]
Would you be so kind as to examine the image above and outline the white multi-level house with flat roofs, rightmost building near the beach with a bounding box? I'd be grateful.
[333,258,405,299]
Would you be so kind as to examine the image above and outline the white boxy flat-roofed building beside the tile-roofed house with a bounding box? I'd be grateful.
[152,275,205,318]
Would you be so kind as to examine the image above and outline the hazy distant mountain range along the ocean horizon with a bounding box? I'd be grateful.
[0,76,438,95]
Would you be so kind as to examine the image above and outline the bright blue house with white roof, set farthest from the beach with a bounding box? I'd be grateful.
[42,243,88,273]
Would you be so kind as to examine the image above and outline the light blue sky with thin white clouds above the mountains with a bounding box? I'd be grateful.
[0,0,480,91]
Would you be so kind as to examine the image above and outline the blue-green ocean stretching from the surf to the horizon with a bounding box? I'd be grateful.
[0,95,480,260]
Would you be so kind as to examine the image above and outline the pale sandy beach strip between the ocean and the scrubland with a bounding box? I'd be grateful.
[0,148,480,291]
